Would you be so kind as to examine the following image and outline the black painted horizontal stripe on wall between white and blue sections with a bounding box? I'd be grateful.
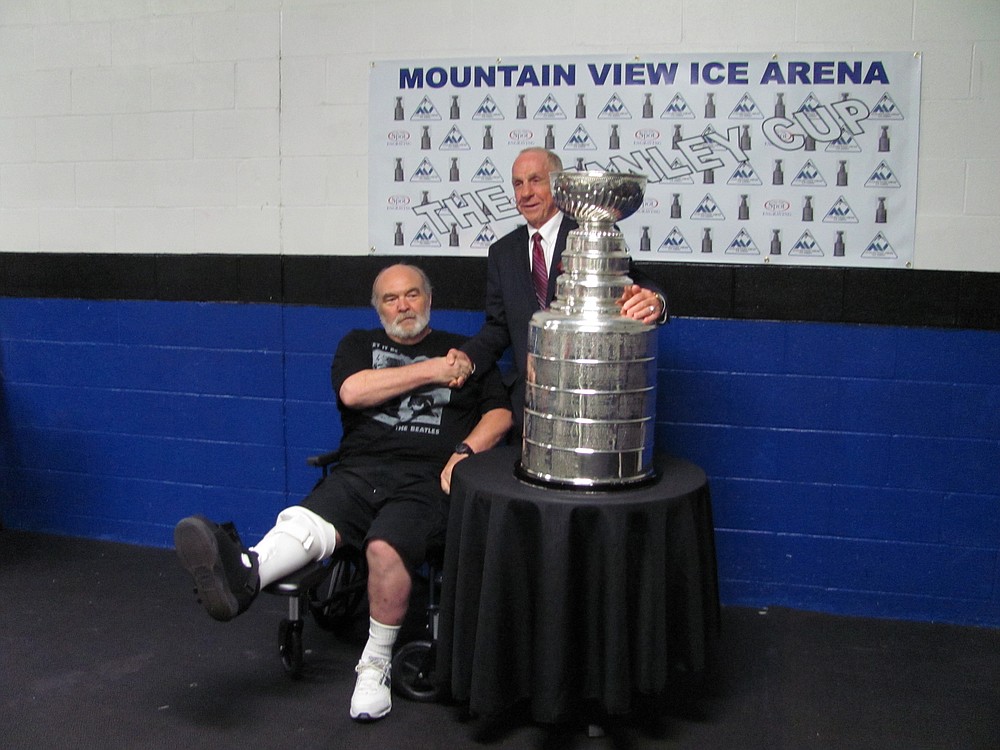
[0,253,1000,330]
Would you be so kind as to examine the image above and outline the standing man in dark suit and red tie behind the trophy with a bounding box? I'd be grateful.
[459,148,667,427]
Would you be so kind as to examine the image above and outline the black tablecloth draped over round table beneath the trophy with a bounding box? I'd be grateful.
[438,447,719,722]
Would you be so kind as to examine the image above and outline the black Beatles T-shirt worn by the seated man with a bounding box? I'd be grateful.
[331,328,510,467]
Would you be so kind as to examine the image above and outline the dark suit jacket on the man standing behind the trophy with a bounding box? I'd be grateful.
[462,215,666,425]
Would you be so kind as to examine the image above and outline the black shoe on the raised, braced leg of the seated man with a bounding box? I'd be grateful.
[174,516,260,622]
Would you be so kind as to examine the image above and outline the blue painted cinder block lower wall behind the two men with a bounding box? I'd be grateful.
[0,297,1000,626]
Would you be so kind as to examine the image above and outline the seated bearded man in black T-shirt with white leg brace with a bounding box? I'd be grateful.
[174,265,512,721]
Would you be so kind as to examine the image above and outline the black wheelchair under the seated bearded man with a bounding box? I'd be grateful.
[264,451,443,702]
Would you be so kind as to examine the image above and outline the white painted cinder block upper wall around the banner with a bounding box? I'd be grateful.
[0,0,1000,272]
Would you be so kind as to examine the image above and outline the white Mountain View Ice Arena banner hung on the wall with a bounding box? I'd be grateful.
[368,52,920,267]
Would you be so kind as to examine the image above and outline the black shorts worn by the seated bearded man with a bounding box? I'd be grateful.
[301,462,448,570]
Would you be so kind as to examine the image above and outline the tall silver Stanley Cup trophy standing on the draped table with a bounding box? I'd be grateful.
[517,171,657,489]
